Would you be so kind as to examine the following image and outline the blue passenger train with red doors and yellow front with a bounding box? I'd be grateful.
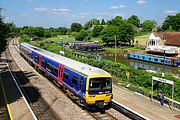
[19,43,113,110]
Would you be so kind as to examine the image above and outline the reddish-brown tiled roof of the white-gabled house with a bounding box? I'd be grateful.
[154,32,180,46]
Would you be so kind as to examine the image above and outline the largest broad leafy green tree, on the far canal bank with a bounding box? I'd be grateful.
[102,16,135,45]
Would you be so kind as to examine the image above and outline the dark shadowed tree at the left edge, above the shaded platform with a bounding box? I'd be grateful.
[0,8,9,53]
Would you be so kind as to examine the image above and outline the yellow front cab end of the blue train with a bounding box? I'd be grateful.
[86,75,113,109]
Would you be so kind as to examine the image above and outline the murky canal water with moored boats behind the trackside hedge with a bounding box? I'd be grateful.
[71,50,180,77]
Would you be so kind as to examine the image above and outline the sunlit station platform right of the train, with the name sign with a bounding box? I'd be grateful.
[113,85,180,120]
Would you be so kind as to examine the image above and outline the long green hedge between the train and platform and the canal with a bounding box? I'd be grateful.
[20,38,180,101]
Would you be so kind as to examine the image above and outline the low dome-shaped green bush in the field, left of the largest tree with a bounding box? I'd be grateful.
[75,30,91,41]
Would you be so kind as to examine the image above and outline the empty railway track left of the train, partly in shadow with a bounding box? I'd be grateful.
[6,39,60,120]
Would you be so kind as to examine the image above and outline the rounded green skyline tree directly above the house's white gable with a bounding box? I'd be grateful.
[142,20,153,32]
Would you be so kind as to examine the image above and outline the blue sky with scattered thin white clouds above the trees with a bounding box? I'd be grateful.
[0,0,180,28]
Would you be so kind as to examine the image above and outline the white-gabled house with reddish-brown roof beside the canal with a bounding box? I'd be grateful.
[146,32,180,57]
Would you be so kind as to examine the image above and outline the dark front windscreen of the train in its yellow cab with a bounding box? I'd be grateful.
[89,78,112,92]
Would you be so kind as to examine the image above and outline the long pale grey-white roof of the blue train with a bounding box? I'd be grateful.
[21,43,110,76]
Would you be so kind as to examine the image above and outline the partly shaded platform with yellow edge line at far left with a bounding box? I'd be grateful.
[0,52,34,120]
